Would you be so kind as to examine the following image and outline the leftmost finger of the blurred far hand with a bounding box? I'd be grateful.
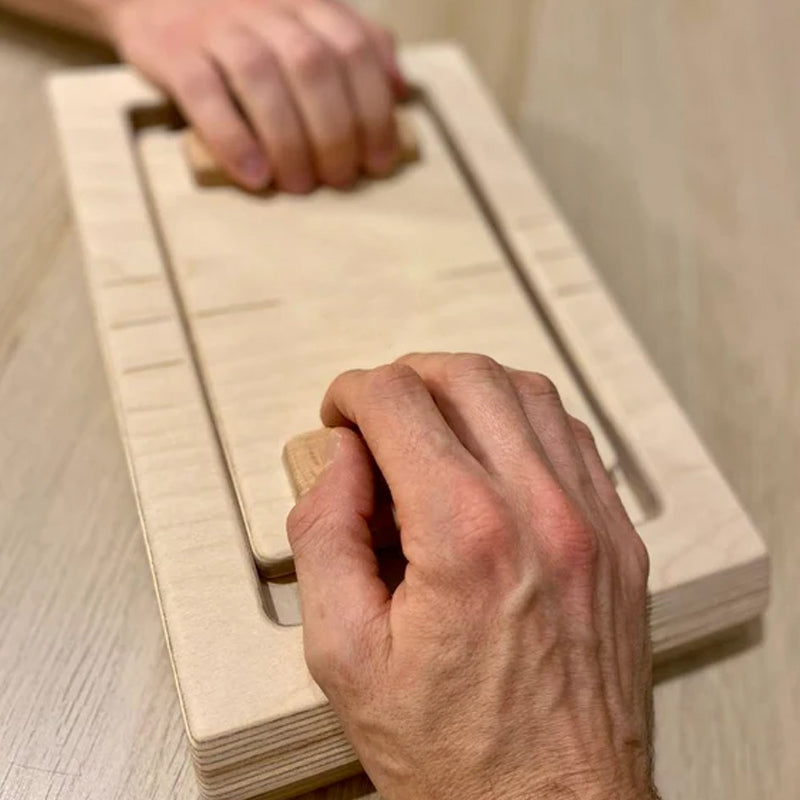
[166,56,270,190]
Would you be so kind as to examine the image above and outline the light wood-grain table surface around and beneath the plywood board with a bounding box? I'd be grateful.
[0,0,800,800]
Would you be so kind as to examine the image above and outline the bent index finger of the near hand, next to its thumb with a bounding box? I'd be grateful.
[321,364,480,520]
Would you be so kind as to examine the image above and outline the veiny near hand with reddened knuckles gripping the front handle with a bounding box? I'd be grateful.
[287,354,655,800]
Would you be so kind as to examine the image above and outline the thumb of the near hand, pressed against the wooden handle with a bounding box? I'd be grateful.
[286,430,390,667]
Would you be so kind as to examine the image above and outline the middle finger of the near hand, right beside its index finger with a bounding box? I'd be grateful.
[398,353,553,485]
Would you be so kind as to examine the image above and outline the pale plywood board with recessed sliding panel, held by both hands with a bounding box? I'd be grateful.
[51,45,768,800]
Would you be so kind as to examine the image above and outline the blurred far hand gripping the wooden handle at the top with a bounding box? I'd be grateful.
[106,0,404,193]
